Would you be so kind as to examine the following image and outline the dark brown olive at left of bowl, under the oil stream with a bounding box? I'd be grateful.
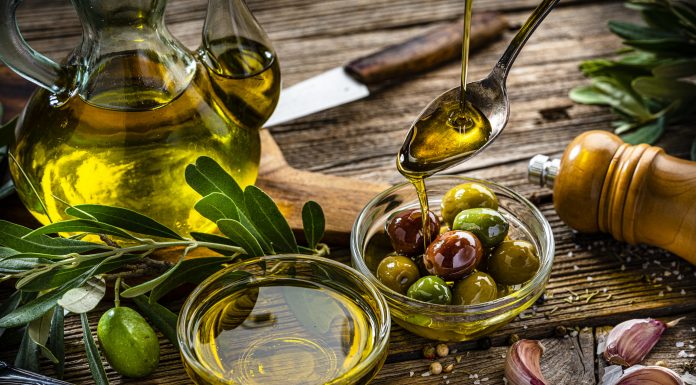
[387,209,440,255]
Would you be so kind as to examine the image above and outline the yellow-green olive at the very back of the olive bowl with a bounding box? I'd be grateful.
[441,183,498,225]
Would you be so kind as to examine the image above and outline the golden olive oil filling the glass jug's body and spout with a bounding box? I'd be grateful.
[10,39,280,234]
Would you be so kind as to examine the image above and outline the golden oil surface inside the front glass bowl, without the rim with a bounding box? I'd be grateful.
[194,279,376,385]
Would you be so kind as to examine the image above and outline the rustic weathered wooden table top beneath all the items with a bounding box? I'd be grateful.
[0,0,696,385]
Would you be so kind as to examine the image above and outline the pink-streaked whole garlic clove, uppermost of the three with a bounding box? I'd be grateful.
[604,318,667,366]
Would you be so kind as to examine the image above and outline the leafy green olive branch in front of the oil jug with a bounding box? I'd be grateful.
[0,157,328,379]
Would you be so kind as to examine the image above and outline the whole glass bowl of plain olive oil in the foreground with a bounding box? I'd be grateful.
[177,255,391,385]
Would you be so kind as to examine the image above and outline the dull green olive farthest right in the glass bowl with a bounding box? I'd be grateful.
[488,241,539,285]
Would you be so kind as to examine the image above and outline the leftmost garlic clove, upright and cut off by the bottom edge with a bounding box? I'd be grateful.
[505,340,547,385]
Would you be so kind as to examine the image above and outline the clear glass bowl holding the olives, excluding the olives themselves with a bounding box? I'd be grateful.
[350,176,554,341]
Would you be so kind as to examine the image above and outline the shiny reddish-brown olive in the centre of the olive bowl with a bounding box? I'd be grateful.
[423,230,483,281]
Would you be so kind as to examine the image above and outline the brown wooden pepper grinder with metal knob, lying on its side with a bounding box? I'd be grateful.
[528,131,696,264]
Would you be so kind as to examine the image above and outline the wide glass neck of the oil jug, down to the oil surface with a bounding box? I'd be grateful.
[70,0,196,110]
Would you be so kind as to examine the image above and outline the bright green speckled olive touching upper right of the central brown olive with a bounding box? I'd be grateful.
[452,208,510,247]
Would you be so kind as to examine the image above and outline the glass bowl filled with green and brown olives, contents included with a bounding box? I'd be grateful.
[350,176,554,341]
